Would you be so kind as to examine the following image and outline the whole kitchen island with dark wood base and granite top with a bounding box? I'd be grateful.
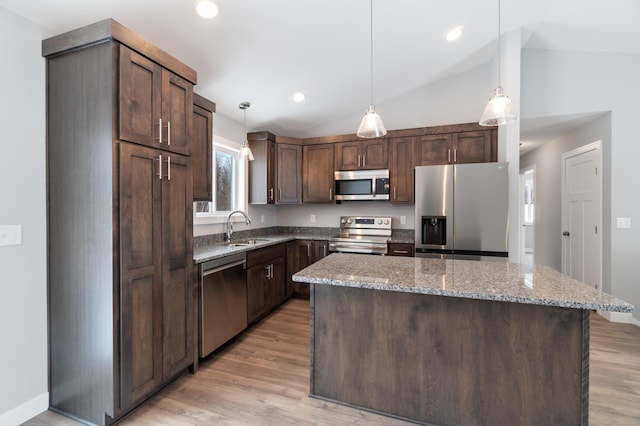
[293,254,633,425]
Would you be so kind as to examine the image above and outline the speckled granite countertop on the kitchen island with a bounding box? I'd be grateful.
[293,253,633,312]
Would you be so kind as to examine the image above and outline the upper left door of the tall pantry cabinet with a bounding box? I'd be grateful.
[118,45,166,147]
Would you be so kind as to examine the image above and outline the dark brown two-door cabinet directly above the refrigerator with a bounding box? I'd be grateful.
[414,129,498,166]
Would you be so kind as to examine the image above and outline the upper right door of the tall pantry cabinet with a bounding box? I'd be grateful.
[162,69,193,155]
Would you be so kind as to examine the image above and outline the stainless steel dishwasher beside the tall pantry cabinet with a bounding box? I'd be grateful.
[200,253,247,358]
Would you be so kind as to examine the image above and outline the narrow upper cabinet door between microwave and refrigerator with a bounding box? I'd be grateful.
[389,137,413,203]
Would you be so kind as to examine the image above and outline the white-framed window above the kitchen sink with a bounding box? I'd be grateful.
[194,137,247,224]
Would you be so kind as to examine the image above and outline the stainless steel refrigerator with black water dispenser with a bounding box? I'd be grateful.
[415,163,509,261]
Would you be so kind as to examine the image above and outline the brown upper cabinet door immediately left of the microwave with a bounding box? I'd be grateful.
[302,144,333,203]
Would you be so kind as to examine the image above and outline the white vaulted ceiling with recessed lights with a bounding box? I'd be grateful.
[0,0,640,143]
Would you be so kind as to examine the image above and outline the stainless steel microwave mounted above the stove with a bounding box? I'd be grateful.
[334,170,389,201]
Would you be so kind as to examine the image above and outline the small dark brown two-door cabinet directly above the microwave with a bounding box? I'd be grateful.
[335,139,388,170]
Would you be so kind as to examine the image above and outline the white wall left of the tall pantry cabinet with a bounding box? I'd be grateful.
[0,8,49,425]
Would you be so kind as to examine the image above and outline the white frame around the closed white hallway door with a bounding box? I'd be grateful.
[560,140,604,293]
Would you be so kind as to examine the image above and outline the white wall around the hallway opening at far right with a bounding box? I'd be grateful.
[522,50,640,319]
